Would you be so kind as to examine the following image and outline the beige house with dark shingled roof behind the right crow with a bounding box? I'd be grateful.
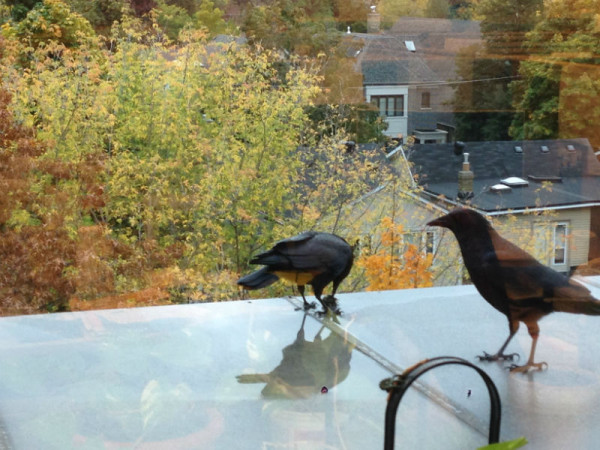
[403,139,600,272]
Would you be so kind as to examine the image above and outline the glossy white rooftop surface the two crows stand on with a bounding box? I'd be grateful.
[0,277,600,450]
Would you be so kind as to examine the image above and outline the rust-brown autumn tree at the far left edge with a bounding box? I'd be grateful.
[0,84,117,314]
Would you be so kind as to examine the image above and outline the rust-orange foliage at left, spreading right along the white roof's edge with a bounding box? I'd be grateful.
[0,89,182,315]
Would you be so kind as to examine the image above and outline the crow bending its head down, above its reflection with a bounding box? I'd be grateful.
[238,231,354,312]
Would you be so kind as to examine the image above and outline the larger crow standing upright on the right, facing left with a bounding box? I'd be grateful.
[428,209,600,372]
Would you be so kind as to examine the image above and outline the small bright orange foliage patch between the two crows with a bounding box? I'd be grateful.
[358,217,433,291]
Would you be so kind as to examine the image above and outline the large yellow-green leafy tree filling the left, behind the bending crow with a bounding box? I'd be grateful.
[0,9,398,310]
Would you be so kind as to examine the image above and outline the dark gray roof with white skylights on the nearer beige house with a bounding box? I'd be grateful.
[407,139,600,212]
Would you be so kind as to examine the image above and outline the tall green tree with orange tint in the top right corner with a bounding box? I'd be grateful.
[511,0,600,146]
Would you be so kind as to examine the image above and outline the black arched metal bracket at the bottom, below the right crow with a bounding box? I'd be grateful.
[379,356,502,450]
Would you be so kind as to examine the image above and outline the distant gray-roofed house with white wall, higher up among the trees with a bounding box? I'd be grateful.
[351,17,481,143]
